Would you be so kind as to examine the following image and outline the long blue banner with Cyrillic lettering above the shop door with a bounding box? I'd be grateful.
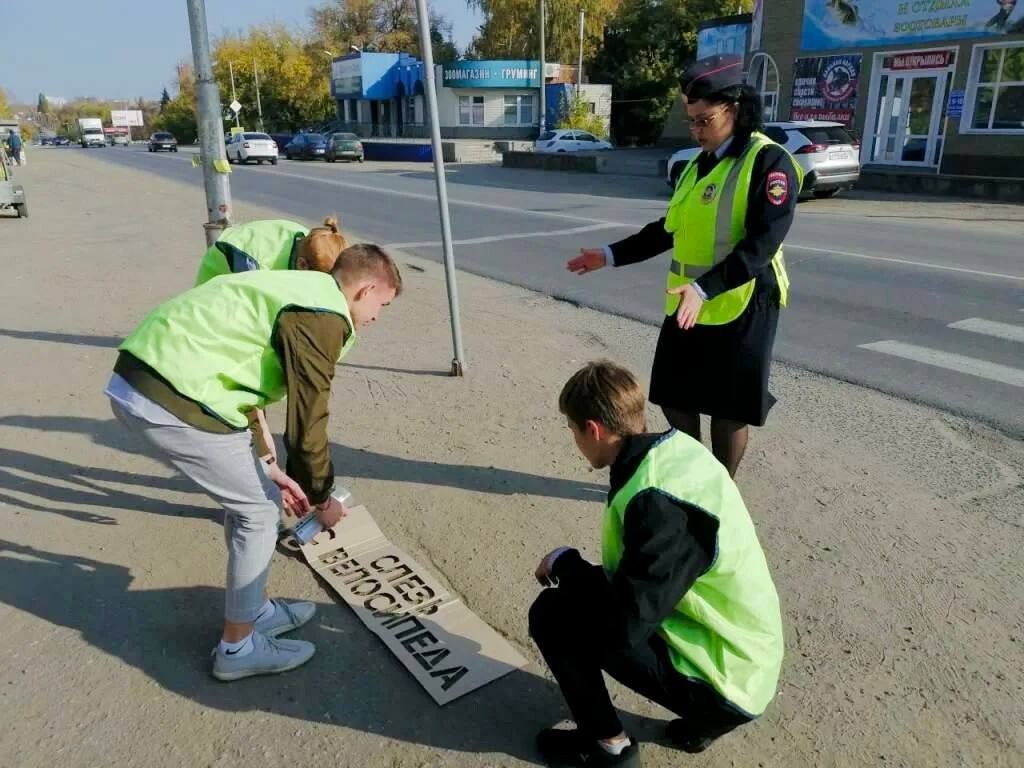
[801,0,1024,50]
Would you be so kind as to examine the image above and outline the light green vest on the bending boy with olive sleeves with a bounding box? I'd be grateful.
[121,270,355,429]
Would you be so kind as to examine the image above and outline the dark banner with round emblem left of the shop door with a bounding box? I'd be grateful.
[792,53,860,126]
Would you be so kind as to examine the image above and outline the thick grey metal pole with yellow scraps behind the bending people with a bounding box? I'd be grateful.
[185,0,231,246]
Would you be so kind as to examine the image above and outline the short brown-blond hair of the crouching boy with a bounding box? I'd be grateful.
[558,360,647,436]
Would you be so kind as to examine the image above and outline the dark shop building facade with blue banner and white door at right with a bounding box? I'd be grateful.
[749,0,1024,177]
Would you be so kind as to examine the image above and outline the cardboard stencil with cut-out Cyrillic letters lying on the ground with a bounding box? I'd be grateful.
[292,507,527,705]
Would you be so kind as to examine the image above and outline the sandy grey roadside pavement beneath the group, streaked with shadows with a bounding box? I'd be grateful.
[0,152,1024,768]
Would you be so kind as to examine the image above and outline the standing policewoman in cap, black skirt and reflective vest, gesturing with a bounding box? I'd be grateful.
[568,56,802,476]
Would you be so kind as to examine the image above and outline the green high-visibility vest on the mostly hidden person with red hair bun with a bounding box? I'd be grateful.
[196,219,309,286]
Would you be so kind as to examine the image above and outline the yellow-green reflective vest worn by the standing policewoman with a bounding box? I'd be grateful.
[665,133,804,326]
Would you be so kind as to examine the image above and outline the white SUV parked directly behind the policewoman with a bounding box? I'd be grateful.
[665,120,860,198]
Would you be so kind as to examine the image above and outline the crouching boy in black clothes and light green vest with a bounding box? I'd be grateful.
[529,361,782,766]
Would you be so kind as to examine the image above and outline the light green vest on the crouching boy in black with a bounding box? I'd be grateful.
[601,430,782,716]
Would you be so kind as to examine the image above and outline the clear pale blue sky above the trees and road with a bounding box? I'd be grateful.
[0,0,480,103]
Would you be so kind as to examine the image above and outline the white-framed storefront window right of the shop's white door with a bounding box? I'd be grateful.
[970,43,1024,132]
